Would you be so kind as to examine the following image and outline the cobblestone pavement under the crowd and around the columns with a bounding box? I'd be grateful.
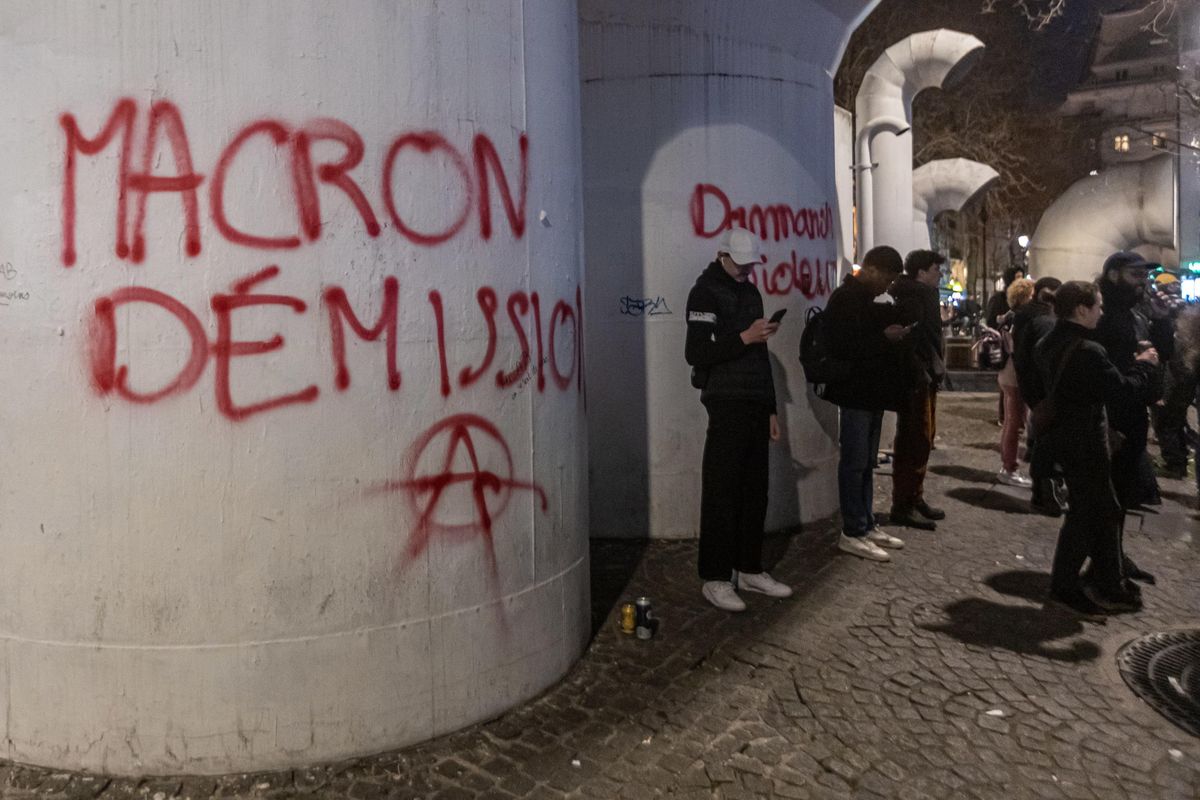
[0,395,1200,800]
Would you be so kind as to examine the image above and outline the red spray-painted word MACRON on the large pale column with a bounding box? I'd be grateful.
[59,98,529,266]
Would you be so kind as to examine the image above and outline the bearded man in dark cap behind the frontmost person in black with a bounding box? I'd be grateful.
[1096,252,1164,510]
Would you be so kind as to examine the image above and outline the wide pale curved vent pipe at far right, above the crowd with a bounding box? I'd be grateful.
[1030,155,1178,281]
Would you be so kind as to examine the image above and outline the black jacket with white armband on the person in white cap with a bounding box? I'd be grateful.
[684,261,775,414]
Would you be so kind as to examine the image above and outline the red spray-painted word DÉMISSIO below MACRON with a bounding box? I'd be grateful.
[86,266,583,421]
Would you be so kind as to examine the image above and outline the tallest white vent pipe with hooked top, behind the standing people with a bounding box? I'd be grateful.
[854,29,984,254]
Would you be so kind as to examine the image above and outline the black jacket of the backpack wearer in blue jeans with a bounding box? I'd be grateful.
[821,277,916,411]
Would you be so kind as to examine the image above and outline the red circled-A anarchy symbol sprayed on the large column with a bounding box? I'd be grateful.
[384,414,548,572]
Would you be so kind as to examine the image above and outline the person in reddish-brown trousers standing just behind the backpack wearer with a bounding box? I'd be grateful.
[888,249,946,530]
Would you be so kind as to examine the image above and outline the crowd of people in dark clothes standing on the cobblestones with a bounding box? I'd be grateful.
[685,228,1200,615]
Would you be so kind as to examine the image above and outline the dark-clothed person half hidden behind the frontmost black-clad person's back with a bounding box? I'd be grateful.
[1010,277,1067,517]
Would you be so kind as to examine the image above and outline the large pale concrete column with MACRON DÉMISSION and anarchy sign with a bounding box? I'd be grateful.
[0,0,588,772]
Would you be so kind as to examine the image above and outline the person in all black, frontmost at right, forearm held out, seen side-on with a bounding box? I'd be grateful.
[1034,281,1162,614]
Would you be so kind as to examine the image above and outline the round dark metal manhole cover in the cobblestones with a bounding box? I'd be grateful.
[1117,631,1200,736]
